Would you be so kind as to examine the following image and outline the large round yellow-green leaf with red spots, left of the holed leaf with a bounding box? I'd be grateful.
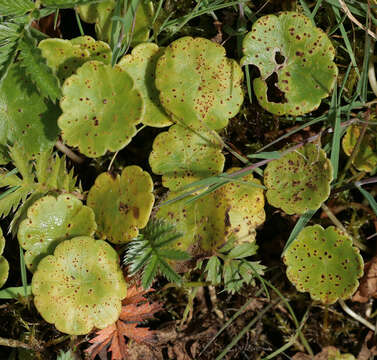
[156,36,243,130]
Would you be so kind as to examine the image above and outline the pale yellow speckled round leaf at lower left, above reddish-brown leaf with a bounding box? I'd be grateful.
[32,236,127,335]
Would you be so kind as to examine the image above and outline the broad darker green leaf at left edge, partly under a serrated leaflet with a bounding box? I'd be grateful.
[0,64,60,160]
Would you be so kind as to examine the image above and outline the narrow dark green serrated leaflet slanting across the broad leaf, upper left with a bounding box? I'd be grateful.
[18,32,61,102]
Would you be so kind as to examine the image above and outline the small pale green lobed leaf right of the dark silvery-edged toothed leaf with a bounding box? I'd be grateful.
[204,238,265,294]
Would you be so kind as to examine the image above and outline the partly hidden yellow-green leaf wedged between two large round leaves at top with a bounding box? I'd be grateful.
[118,43,172,127]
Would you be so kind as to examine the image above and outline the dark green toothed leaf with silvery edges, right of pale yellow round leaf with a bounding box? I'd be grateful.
[124,220,190,289]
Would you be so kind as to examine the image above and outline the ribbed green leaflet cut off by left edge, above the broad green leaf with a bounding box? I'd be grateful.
[0,22,22,81]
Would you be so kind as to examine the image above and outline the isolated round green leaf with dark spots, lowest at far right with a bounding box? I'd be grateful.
[283,225,363,304]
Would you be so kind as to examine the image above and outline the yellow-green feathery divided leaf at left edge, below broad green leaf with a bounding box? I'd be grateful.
[0,146,77,235]
